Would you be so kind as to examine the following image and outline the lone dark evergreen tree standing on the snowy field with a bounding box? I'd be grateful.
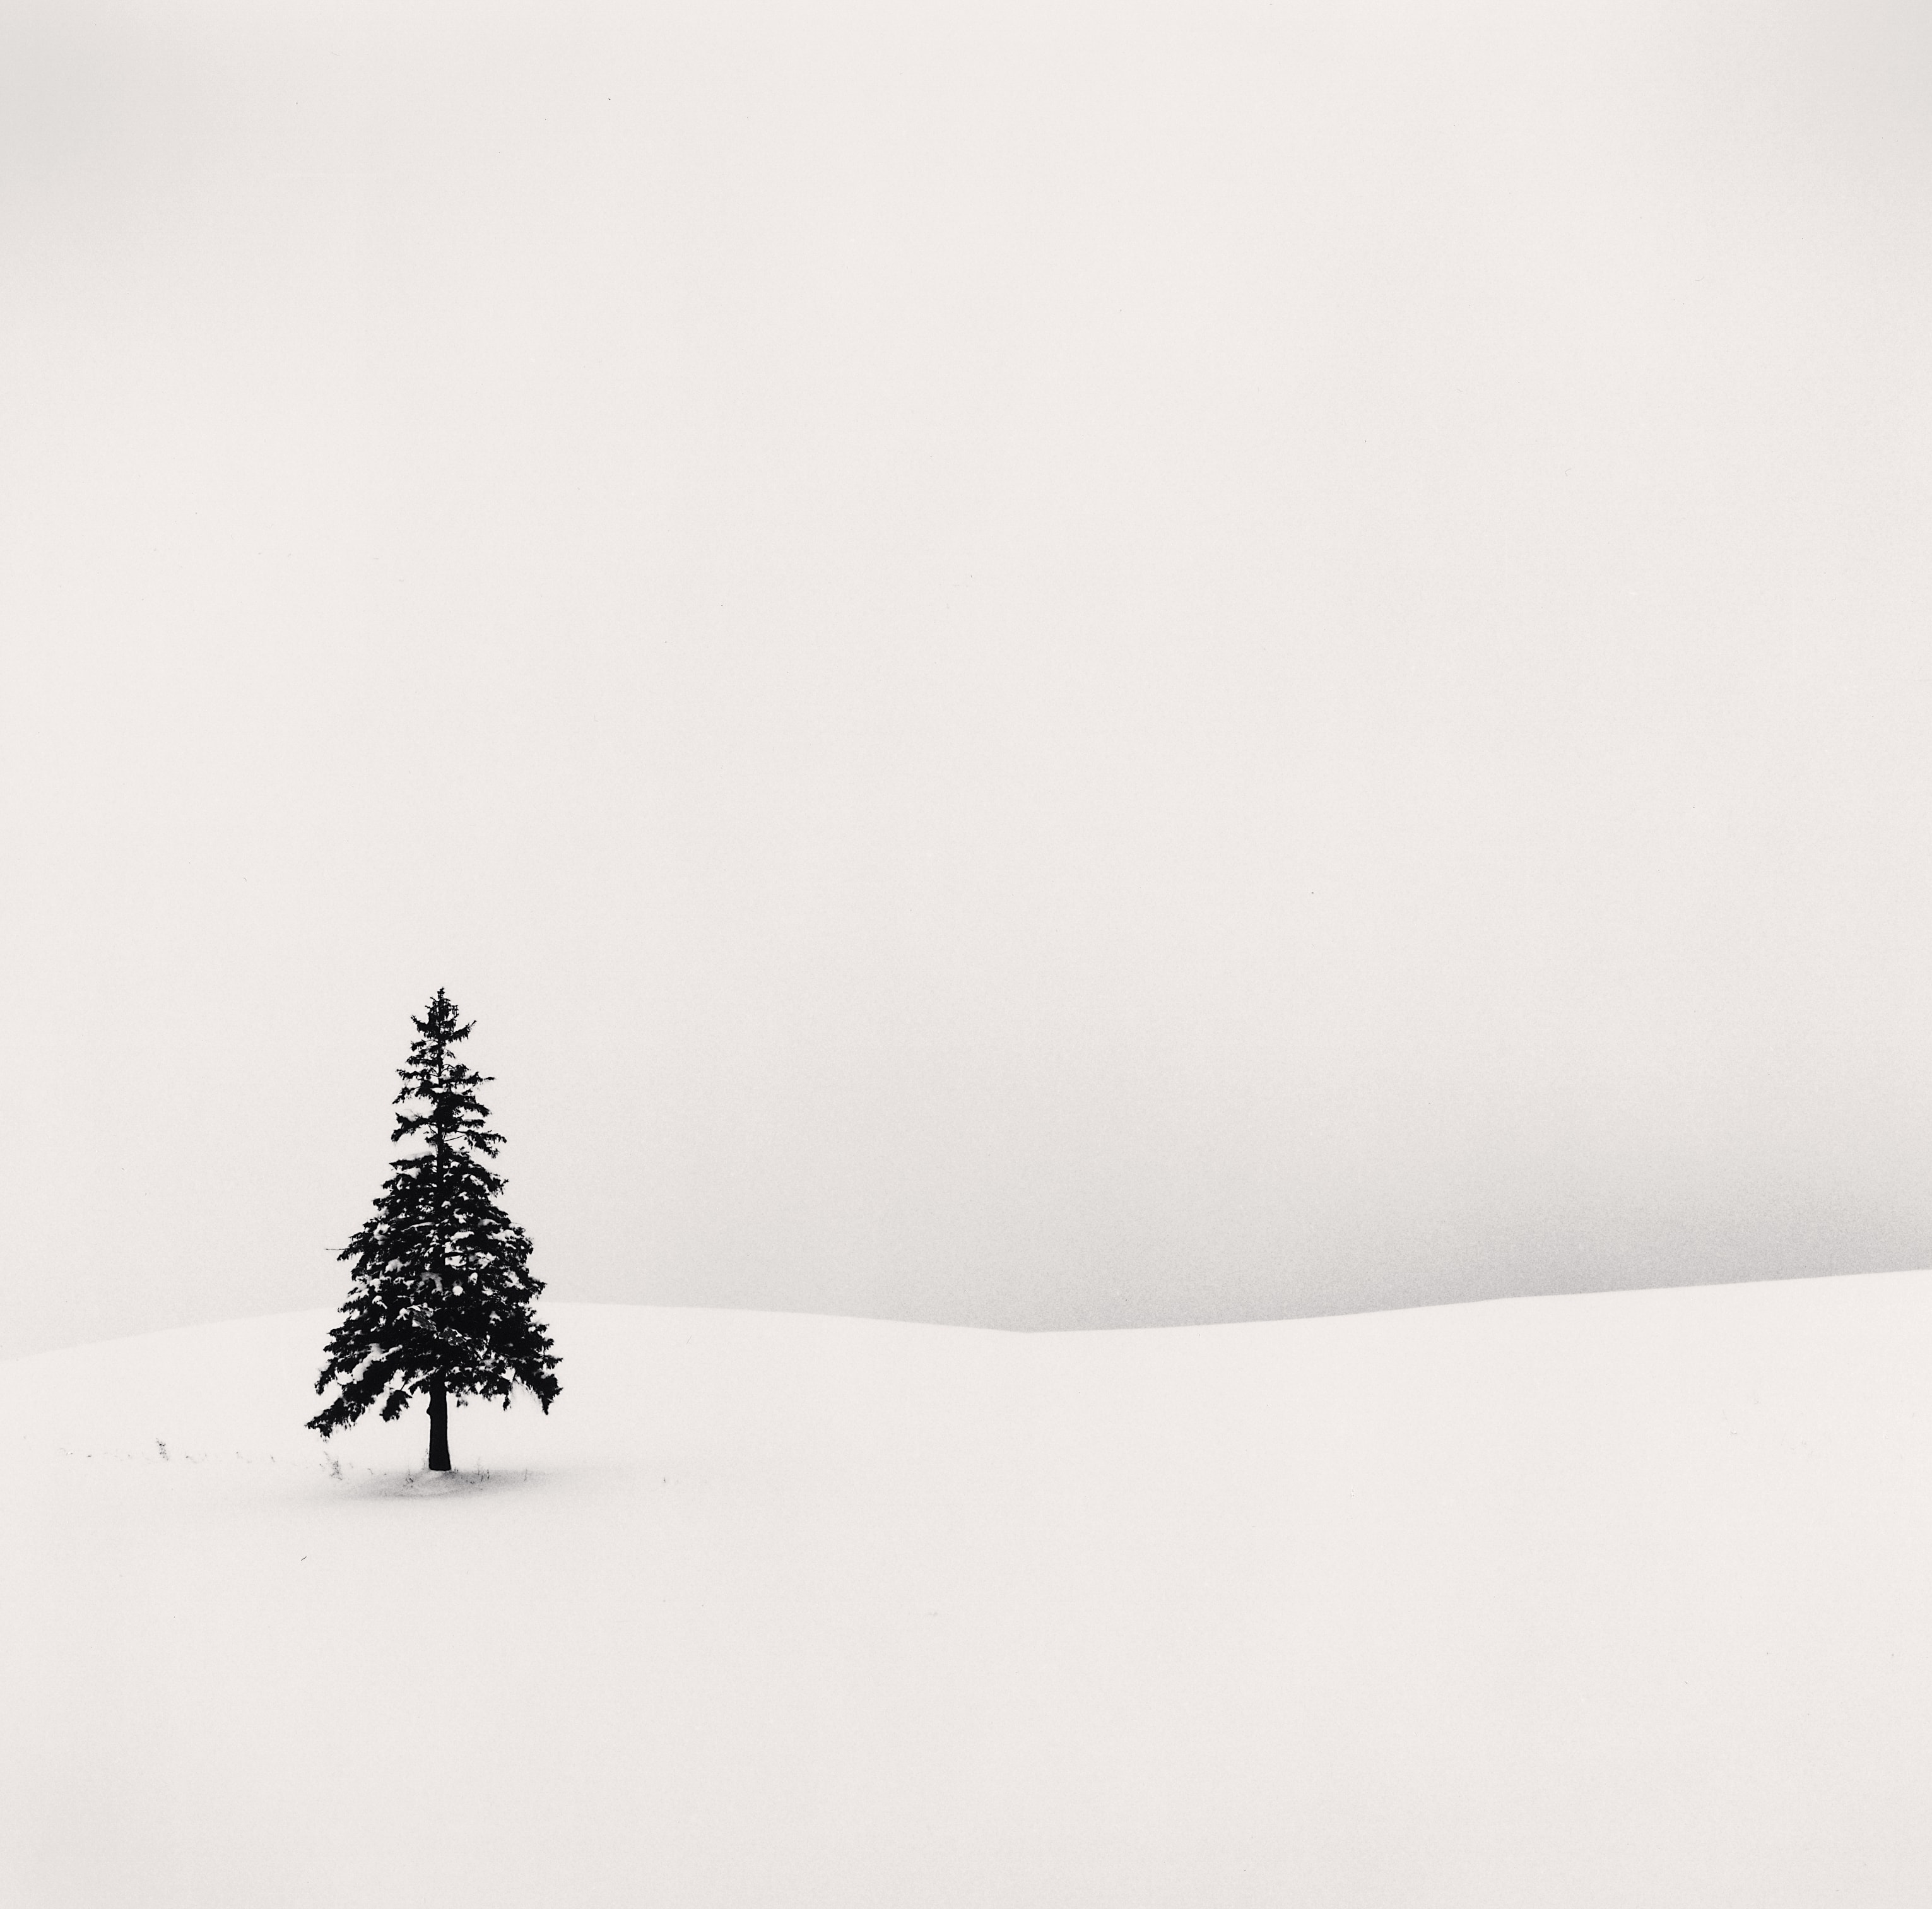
[309,988,560,1472]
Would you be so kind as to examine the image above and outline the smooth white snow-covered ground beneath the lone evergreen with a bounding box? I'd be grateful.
[0,1274,1932,1909]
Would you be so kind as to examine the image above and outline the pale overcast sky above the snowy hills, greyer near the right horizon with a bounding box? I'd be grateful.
[0,0,1932,1350]
